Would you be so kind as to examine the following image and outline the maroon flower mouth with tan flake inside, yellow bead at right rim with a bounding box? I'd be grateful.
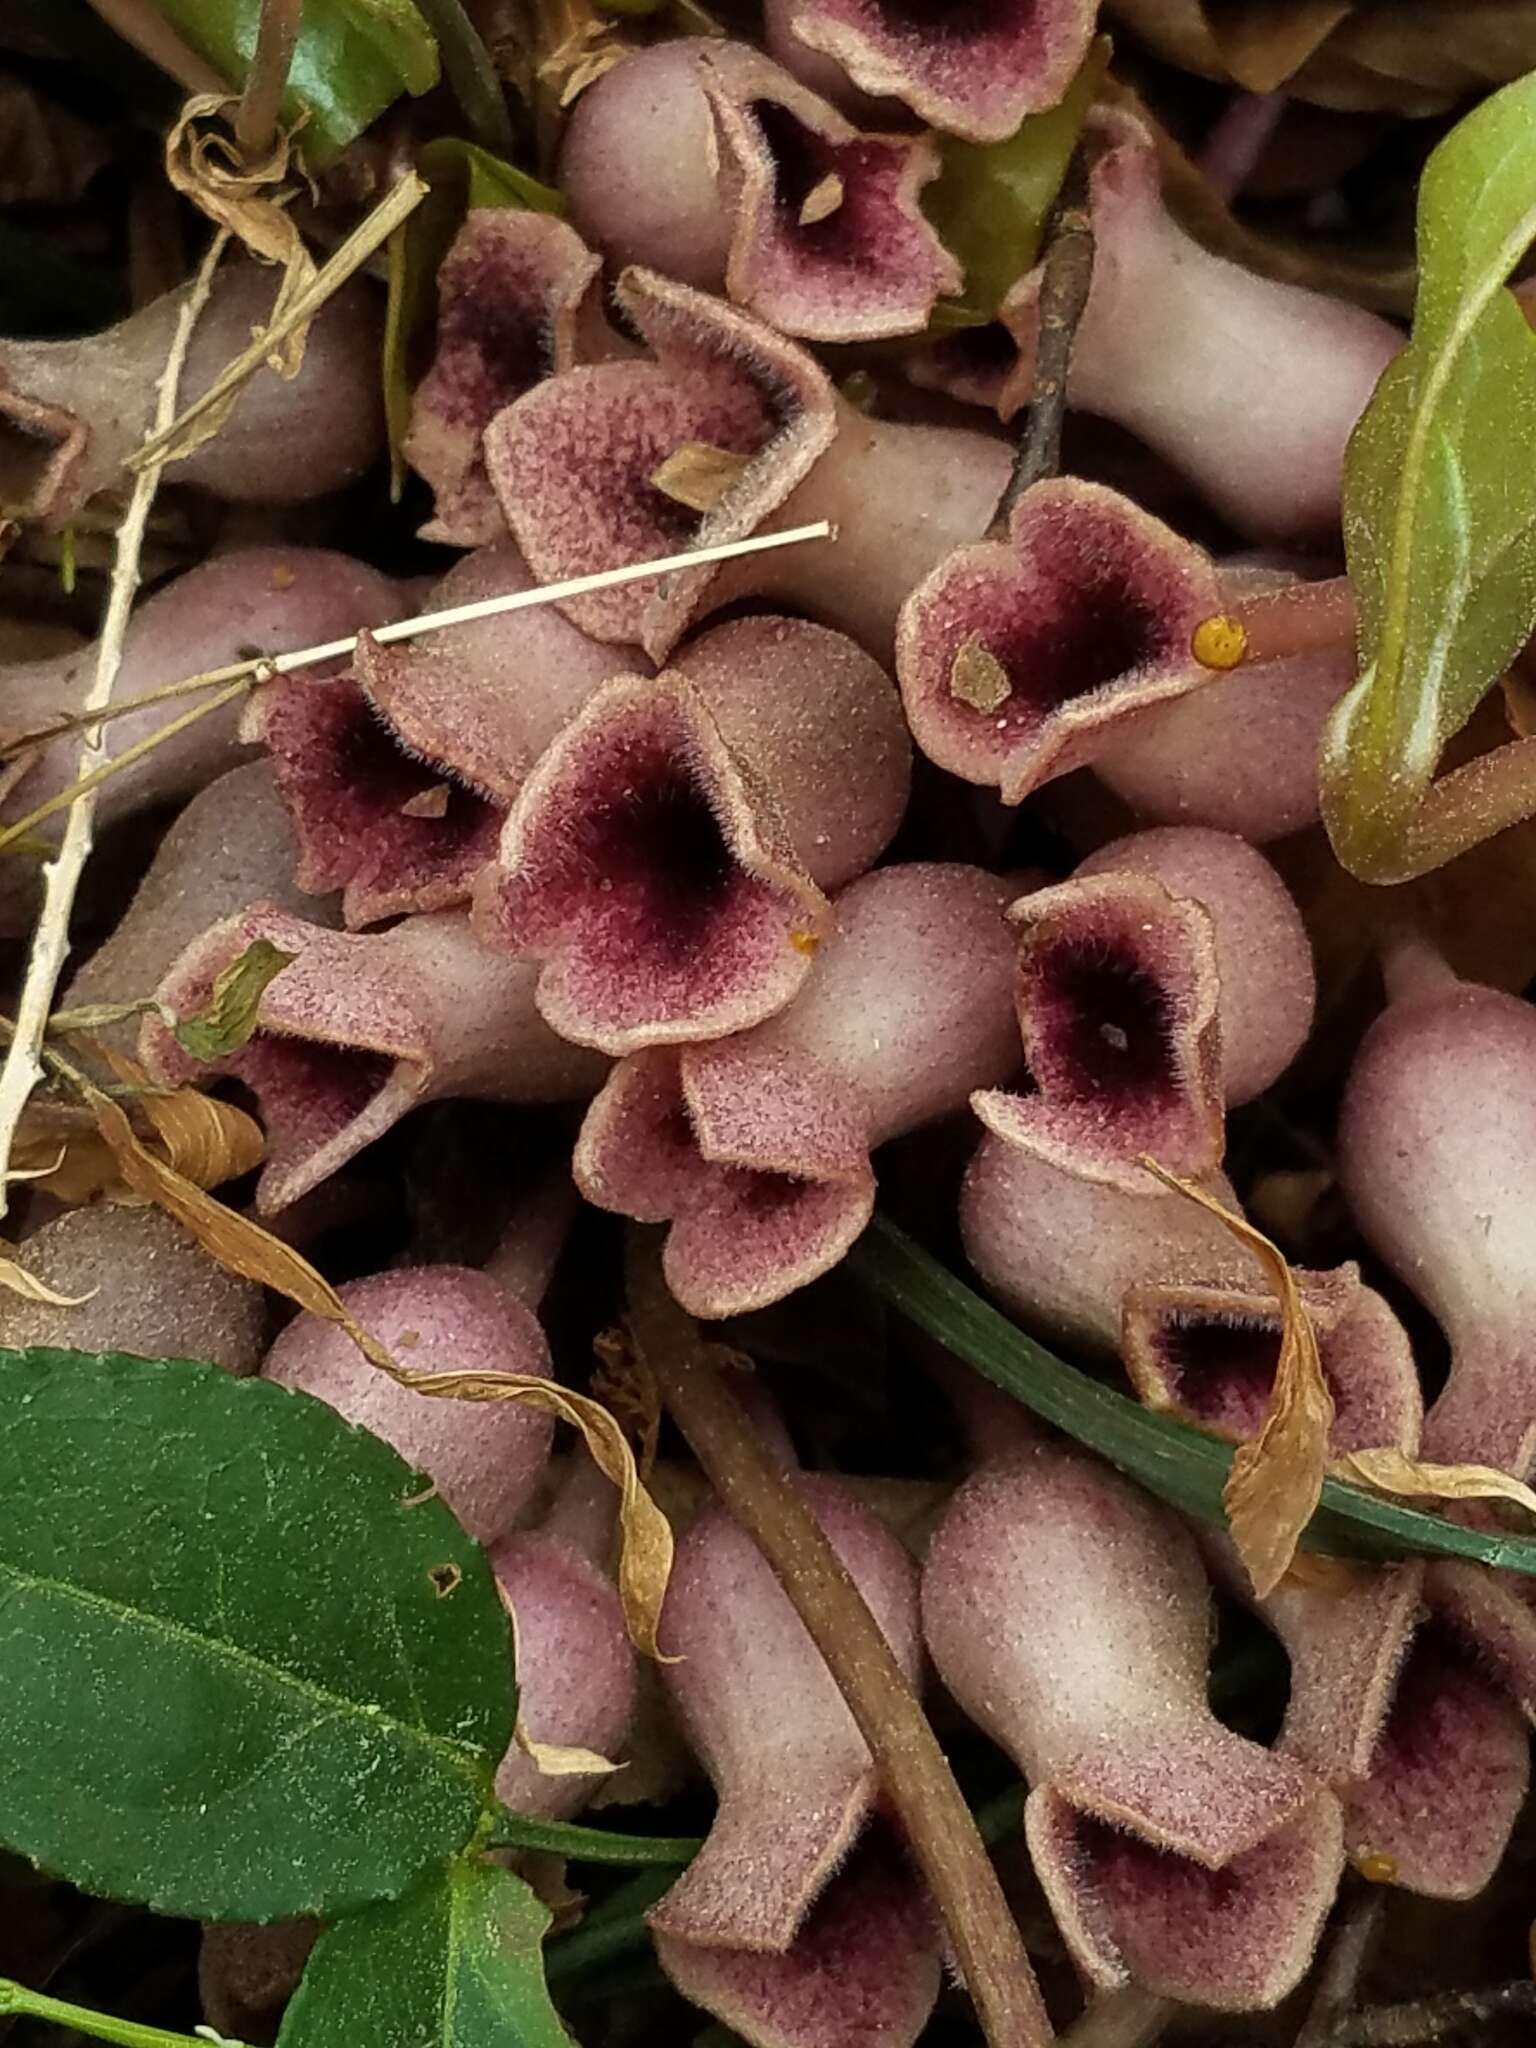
[897,479,1219,803]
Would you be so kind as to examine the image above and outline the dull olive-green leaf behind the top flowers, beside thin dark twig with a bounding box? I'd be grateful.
[922,37,1110,332]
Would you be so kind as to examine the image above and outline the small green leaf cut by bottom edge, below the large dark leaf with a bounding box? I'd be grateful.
[279,1860,571,2048]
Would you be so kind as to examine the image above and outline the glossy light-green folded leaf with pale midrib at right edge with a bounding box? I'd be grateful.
[1323,74,1536,881]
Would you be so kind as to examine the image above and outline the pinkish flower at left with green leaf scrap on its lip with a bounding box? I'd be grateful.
[141,905,604,1214]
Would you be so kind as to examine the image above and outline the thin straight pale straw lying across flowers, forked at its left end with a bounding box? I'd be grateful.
[0,520,838,852]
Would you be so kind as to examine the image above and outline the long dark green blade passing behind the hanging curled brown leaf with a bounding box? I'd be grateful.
[848,1217,1536,1577]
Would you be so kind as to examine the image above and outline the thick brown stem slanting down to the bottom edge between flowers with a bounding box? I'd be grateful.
[627,1231,1055,2048]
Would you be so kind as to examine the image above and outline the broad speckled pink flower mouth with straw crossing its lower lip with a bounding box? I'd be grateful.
[485,270,836,659]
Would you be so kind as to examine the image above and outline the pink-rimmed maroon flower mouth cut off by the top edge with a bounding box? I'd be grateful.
[764,0,1096,141]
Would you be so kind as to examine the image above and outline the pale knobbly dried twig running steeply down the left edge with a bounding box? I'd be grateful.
[0,233,229,1217]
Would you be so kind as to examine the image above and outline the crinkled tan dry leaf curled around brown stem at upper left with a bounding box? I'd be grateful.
[166,92,317,411]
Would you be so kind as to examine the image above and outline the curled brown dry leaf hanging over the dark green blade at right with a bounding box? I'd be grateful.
[1139,1153,1333,1599]
